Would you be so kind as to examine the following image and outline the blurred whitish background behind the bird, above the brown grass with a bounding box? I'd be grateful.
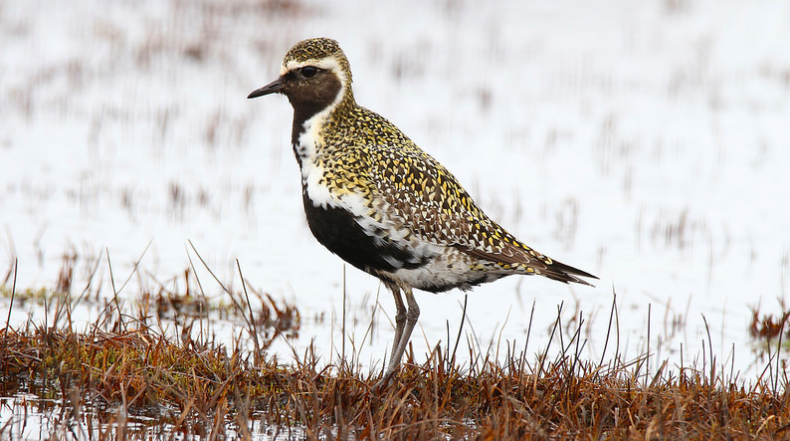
[0,0,790,373]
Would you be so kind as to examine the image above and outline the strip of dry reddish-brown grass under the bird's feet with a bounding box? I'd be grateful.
[0,258,790,440]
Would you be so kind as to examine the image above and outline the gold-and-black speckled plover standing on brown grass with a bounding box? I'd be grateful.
[247,38,597,385]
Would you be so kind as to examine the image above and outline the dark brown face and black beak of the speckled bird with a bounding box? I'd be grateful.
[247,65,342,119]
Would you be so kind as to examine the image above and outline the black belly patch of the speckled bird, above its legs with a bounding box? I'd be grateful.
[303,191,428,273]
